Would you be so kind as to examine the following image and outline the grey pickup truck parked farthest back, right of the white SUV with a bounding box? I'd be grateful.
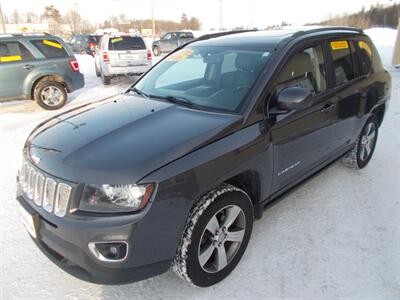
[152,31,194,56]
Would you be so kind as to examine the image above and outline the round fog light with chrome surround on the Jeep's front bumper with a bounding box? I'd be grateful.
[89,241,128,262]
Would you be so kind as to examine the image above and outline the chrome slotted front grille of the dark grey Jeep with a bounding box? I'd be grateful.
[19,161,72,217]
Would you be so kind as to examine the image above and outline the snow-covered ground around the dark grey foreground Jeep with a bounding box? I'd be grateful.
[0,29,400,300]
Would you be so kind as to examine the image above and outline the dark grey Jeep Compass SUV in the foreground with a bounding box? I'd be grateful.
[17,28,391,287]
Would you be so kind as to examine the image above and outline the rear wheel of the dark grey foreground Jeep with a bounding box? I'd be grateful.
[343,115,379,169]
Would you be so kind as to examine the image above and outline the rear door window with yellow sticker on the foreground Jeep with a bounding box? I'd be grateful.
[330,41,355,85]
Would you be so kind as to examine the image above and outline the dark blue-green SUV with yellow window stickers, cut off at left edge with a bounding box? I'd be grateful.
[0,34,85,110]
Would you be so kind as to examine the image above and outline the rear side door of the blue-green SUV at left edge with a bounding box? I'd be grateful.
[0,41,35,98]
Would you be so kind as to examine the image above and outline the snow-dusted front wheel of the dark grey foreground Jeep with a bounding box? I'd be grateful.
[172,184,254,287]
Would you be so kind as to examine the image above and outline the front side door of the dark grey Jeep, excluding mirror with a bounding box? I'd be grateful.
[269,42,343,192]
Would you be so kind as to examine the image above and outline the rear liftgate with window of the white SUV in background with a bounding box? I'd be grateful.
[108,35,147,67]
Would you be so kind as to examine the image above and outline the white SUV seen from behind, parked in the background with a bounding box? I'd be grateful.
[95,33,152,85]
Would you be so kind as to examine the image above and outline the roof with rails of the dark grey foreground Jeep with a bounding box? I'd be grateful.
[193,26,363,47]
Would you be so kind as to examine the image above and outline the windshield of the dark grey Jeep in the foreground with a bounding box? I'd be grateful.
[135,46,271,112]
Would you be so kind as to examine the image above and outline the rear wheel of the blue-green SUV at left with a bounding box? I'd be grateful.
[33,80,67,110]
